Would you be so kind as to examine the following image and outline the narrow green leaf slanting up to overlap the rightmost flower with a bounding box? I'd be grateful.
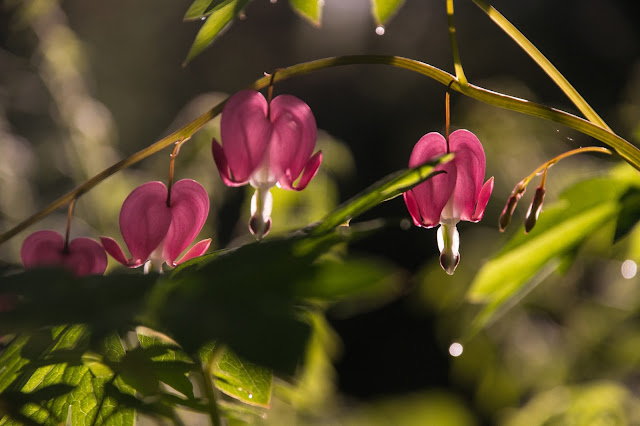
[311,154,453,235]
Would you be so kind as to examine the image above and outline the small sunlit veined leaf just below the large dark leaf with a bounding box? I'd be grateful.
[213,349,273,407]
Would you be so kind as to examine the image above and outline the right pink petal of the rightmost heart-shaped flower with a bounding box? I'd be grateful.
[449,129,486,221]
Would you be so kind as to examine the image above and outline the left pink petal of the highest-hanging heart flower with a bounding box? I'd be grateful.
[221,90,273,182]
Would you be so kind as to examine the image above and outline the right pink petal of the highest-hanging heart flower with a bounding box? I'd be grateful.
[269,95,318,183]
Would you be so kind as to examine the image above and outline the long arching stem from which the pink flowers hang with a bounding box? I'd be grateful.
[0,55,640,244]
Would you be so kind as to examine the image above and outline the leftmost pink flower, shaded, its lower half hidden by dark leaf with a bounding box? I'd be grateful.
[20,230,107,277]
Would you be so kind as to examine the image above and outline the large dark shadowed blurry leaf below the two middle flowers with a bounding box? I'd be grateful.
[147,239,318,374]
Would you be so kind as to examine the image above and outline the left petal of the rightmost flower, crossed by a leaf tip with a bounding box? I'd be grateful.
[409,132,457,228]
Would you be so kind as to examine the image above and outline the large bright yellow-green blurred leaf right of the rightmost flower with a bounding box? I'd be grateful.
[467,177,631,334]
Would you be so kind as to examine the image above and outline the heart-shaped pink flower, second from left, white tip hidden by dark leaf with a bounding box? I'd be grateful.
[100,179,211,272]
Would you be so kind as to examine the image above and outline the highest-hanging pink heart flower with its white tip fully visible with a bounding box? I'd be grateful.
[211,90,322,238]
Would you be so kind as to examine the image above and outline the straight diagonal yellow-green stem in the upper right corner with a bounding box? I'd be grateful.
[470,0,608,131]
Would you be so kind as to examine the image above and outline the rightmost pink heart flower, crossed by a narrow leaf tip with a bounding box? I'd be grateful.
[404,130,493,275]
